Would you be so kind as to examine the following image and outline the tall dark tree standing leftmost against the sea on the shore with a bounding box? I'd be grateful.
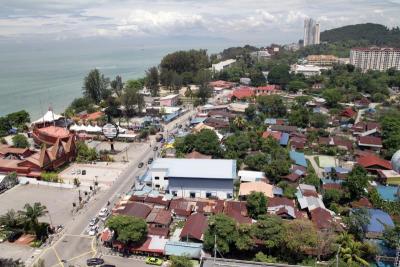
[83,69,109,104]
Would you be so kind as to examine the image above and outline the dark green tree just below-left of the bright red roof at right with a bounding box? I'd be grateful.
[343,165,369,200]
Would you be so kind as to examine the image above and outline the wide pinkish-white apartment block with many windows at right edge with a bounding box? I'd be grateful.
[350,47,400,71]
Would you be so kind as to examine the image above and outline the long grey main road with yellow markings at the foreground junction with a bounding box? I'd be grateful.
[32,110,195,267]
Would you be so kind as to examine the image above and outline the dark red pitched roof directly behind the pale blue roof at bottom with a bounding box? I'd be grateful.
[180,213,207,241]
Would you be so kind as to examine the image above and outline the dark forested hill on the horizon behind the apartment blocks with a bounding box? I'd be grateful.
[321,23,400,47]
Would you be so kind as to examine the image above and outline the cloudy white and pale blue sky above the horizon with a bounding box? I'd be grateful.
[0,0,400,44]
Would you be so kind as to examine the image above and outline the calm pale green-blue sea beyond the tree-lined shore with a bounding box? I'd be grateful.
[0,40,227,120]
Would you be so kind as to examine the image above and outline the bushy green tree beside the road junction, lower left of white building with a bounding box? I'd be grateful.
[106,215,147,244]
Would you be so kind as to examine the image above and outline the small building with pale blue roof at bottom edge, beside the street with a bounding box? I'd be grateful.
[164,241,203,259]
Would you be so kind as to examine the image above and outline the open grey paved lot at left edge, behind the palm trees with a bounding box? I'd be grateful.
[0,184,78,225]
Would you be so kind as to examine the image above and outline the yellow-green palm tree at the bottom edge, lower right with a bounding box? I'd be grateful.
[338,233,369,266]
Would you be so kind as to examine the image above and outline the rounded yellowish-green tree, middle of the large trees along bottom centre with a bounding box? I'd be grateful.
[253,215,284,251]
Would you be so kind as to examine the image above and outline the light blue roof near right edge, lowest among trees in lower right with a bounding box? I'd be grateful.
[364,209,394,238]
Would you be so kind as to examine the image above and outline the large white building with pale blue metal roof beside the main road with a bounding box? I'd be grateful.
[149,158,236,199]
